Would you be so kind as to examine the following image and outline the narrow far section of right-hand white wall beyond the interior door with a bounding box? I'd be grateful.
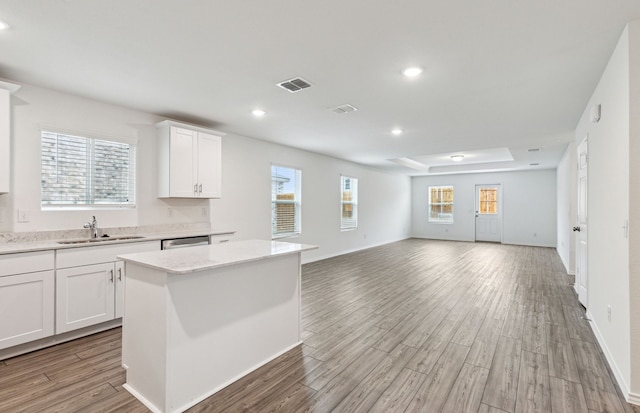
[556,142,577,275]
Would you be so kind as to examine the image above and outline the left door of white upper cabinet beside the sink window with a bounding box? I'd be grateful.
[170,127,198,198]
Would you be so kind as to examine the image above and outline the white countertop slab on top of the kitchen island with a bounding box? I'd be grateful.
[118,240,318,274]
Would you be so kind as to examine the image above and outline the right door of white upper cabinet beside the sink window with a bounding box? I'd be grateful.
[197,132,222,198]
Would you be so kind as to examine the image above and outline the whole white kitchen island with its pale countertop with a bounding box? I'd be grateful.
[119,240,316,412]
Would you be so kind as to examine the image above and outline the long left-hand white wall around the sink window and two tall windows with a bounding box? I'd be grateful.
[0,78,411,260]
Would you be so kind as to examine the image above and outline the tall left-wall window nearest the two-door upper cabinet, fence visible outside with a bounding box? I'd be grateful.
[271,165,302,238]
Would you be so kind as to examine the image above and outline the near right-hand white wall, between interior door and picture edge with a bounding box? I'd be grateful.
[576,23,640,400]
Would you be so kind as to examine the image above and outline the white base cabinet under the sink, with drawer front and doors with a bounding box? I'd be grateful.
[56,241,159,334]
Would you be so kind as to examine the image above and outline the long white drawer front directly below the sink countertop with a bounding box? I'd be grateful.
[56,241,160,268]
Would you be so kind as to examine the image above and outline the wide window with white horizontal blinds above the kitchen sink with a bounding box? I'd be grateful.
[41,131,136,207]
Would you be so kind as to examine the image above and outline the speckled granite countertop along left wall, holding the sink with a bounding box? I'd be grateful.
[0,225,235,255]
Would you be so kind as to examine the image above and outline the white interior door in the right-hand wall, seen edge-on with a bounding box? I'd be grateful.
[573,138,589,307]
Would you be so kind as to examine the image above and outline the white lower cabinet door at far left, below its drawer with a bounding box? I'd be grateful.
[0,271,55,349]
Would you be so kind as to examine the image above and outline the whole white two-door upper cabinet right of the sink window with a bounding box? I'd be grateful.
[156,121,224,198]
